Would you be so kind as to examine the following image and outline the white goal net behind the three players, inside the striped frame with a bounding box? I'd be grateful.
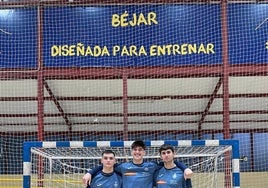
[31,146,231,188]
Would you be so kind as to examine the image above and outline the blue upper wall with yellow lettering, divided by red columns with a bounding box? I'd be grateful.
[0,4,268,68]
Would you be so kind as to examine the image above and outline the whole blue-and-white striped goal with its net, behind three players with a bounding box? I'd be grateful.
[23,140,240,188]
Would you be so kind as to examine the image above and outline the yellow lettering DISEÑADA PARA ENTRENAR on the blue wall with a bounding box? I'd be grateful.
[50,42,216,57]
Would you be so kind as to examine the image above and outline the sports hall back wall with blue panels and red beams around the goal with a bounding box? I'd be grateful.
[0,0,268,188]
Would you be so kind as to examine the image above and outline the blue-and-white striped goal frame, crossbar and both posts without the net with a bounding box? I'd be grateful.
[23,140,240,188]
